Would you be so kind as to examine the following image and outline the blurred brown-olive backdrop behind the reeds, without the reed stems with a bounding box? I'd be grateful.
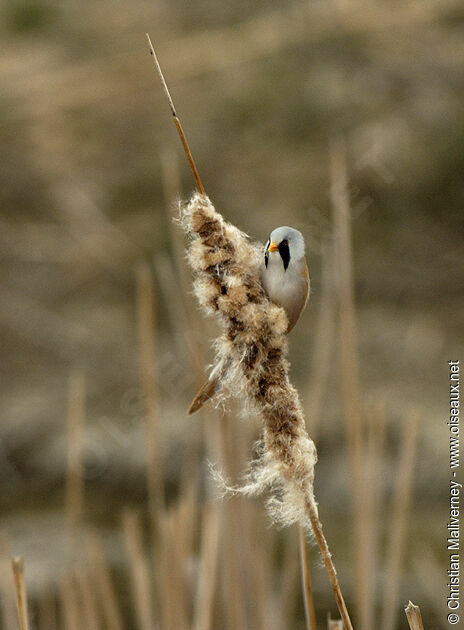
[0,0,464,630]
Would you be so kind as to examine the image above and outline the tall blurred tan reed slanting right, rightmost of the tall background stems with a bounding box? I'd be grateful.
[380,412,419,630]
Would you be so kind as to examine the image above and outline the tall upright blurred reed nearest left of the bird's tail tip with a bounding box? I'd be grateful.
[136,264,164,518]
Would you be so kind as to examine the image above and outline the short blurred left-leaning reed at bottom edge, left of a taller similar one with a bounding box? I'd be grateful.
[86,532,123,630]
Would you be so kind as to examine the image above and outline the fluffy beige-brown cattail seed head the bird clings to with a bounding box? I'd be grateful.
[180,193,317,527]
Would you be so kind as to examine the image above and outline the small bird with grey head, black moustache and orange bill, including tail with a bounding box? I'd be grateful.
[188,225,309,415]
